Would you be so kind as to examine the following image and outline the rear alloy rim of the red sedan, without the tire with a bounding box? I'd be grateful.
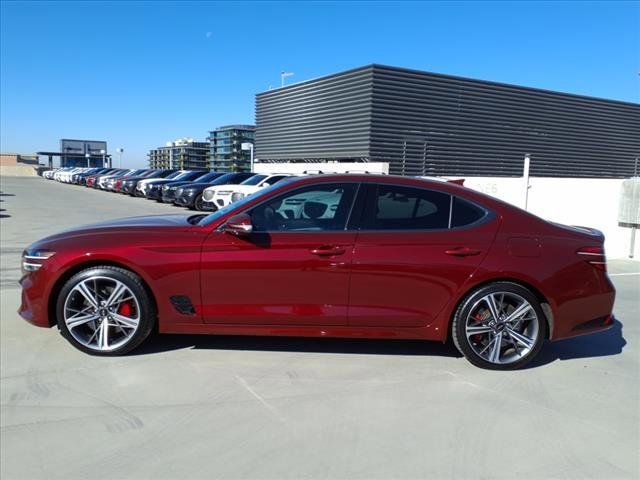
[465,292,540,365]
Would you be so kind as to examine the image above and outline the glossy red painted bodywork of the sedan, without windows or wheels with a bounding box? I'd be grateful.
[19,175,615,340]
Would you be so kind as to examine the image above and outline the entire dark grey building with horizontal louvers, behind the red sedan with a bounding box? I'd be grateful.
[255,65,640,178]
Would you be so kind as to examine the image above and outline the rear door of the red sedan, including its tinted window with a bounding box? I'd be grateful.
[349,184,498,327]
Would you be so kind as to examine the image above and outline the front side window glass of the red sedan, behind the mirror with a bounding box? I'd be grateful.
[247,183,357,232]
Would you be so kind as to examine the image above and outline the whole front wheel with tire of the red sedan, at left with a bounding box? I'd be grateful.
[56,266,156,356]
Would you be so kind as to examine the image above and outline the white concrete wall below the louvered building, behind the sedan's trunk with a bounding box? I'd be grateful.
[464,177,640,260]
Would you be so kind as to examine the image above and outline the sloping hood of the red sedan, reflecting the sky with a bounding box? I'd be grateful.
[32,213,193,247]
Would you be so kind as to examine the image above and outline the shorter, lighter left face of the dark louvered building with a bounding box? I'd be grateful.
[255,67,373,162]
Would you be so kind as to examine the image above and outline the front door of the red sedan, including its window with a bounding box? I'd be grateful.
[201,183,358,326]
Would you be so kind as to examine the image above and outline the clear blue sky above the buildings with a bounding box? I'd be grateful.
[0,1,640,166]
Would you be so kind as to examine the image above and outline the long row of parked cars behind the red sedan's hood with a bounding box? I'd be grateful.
[42,167,291,211]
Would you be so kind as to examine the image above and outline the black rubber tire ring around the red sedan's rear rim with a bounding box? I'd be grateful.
[451,282,547,370]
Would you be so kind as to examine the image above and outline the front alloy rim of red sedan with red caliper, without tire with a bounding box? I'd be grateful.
[63,276,141,352]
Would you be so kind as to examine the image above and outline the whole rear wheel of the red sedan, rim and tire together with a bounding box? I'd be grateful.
[451,282,547,370]
